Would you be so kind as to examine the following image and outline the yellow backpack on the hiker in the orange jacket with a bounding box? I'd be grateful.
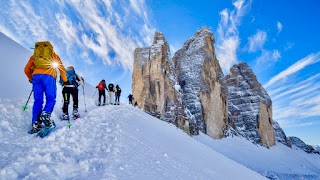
[33,41,53,69]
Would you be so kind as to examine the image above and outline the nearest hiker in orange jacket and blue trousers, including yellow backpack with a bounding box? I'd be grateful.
[24,41,68,134]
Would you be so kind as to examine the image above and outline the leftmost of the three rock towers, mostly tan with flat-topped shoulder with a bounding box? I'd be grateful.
[132,32,189,131]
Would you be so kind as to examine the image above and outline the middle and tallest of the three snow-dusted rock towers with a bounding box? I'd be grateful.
[173,27,228,138]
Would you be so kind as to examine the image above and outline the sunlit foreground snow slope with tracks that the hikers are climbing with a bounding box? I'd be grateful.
[0,98,263,179]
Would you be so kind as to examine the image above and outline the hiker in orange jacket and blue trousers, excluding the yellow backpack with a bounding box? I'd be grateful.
[24,43,68,134]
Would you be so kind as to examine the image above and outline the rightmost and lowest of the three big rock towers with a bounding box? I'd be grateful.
[226,63,275,147]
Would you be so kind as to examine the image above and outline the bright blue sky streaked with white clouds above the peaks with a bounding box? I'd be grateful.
[0,0,320,144]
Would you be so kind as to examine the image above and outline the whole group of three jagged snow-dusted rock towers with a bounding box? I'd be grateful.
[132,27,291,147]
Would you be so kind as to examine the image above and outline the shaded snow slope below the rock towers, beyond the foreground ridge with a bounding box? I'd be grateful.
[195,134,320,179]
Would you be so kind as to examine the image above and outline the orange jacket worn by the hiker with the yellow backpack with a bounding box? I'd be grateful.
[24,52,68,82]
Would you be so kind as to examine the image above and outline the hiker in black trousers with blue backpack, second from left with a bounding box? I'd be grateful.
[60,66,84,120]
